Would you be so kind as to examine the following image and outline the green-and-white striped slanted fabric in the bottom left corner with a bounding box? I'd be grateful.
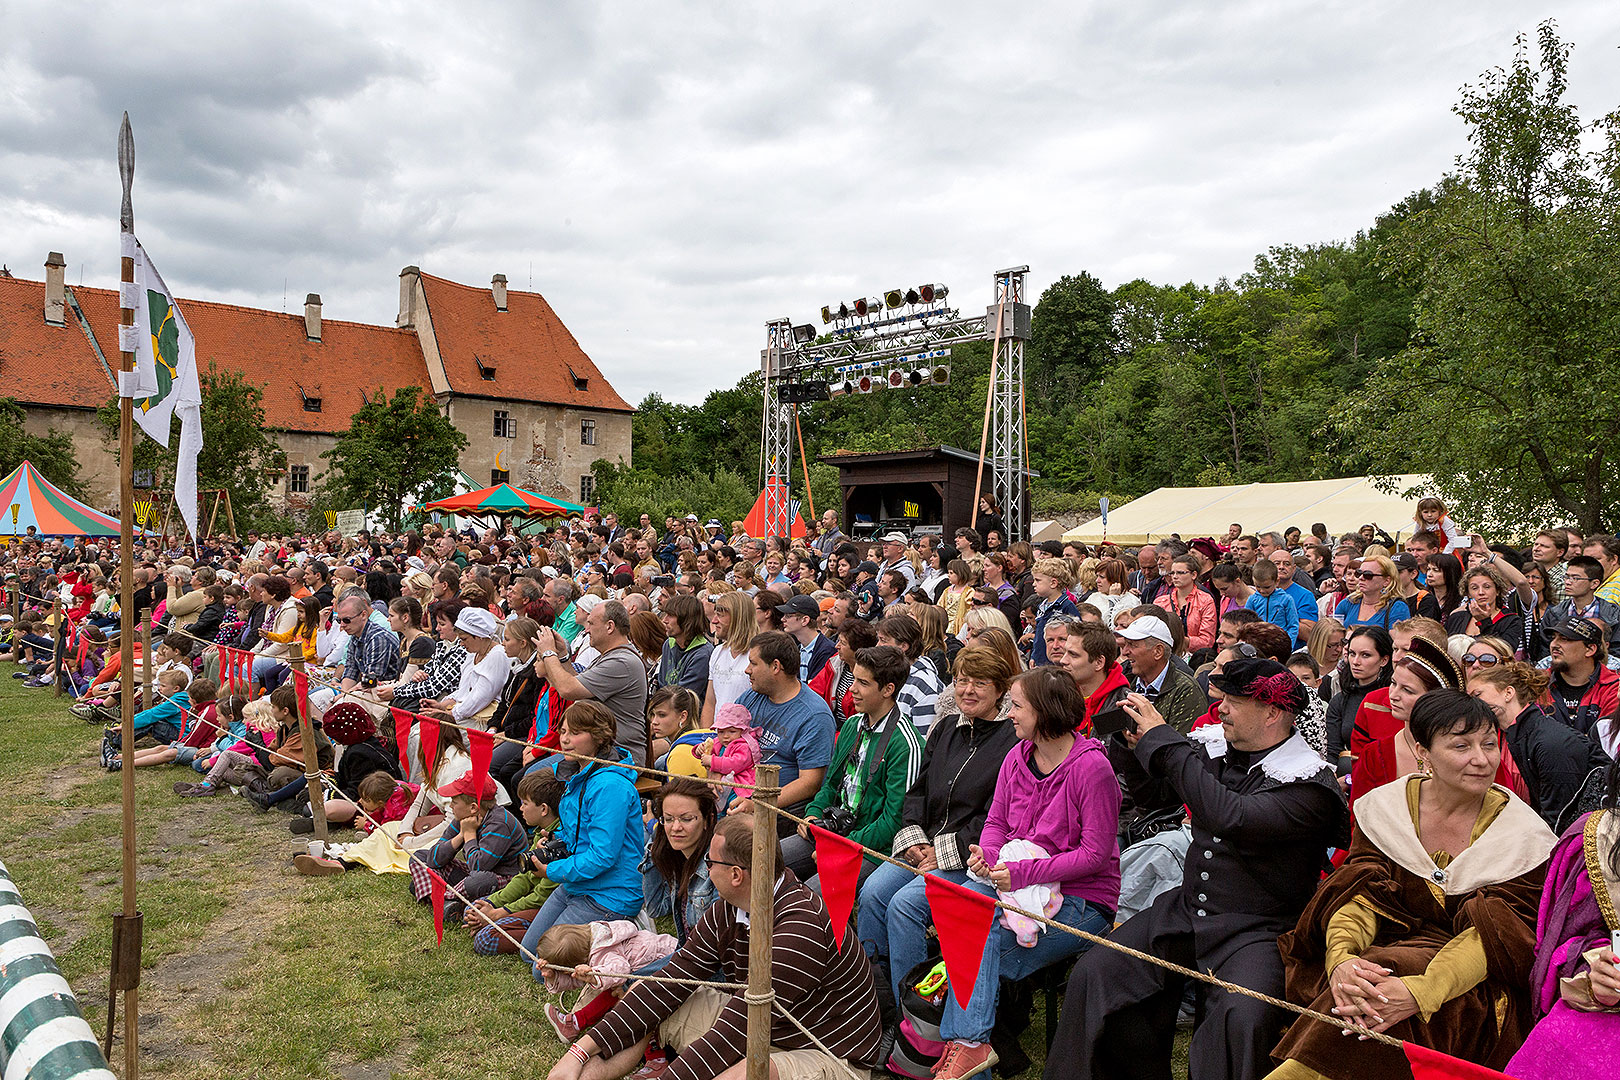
[0,863,113,1080]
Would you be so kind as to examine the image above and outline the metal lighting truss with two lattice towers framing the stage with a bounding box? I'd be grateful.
[760,266,1030,542]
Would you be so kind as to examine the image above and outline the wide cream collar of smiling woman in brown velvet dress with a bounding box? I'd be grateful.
[1356,774,1558,895]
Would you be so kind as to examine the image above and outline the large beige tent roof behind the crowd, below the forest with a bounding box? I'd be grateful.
[1063,474,1427,544]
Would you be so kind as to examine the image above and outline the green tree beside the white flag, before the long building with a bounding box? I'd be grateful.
[97,359,285,528]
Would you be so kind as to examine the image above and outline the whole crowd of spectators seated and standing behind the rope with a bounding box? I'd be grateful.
[0,499,1620,1080]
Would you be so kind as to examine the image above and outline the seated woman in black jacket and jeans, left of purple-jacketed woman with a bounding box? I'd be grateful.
[857,635,1017,999]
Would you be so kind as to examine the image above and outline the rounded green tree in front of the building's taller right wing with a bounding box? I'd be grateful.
[321,387,467,529]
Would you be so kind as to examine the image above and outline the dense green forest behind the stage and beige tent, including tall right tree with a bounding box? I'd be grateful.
[598,24,1620,531]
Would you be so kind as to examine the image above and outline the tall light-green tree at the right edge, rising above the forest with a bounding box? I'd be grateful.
[1341,30,1620,533]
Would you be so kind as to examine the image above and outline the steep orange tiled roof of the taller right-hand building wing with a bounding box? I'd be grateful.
[421,274,633,413]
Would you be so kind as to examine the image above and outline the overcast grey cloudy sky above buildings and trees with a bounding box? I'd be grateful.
[0,0,1620,402]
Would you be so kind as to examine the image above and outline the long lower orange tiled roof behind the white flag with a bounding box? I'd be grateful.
[0,279,431,434]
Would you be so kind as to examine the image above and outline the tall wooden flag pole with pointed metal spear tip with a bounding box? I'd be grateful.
[107,113,152,1080]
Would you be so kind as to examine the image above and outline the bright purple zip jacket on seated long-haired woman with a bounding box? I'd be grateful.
[978,737,1119,912]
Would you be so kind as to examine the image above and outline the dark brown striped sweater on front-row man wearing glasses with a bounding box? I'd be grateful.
[591,870,881,1080]
